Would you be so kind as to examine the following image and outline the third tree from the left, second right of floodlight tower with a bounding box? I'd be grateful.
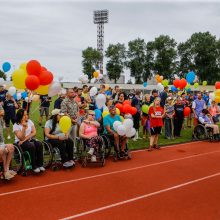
[127,38,146,84]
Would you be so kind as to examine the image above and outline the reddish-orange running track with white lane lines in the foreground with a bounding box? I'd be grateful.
[0,142,220,220]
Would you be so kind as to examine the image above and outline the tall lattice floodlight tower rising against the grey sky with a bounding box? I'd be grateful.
[93,10,108,74]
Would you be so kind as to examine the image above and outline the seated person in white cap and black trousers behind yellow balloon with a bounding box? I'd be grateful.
[44,109,75,167]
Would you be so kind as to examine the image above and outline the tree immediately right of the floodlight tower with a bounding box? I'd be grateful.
[105,43,126,83]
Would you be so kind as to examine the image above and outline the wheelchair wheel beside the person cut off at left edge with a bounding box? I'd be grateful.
[10,145,23,173]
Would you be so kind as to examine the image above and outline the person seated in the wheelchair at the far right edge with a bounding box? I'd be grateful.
[199,109,220,140]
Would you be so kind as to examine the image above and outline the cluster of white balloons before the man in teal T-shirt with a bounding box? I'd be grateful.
[113,119,136,138]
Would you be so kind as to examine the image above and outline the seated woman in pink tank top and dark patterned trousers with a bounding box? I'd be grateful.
[79,110,102,162]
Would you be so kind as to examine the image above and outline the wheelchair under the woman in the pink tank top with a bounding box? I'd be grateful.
[75,137,106,167]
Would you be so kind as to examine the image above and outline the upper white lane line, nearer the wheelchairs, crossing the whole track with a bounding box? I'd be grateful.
[0,150,220,197]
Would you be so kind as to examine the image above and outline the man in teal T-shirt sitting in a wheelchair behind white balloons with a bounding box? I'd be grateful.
[103,105,127,158]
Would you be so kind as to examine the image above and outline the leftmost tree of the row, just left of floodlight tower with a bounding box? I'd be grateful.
[82,47,102,80]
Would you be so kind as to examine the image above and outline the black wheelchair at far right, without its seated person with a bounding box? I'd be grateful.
[193,123,214,142]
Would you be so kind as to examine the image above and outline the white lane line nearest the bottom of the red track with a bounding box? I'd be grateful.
[60,173,220,220]
